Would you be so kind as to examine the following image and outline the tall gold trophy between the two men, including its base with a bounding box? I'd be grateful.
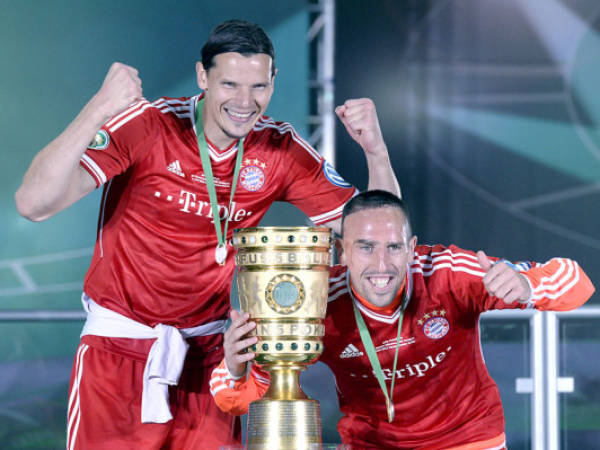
[233,227,332,450]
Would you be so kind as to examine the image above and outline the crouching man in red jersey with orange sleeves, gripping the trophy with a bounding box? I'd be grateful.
[210,191,594,450]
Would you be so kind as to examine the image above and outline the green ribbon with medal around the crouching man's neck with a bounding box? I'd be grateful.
[350,288,406,423]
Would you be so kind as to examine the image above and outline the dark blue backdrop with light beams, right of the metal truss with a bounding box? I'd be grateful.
[336,0,600,449]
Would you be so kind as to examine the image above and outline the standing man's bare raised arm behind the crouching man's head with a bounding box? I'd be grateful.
[326,98,402,234]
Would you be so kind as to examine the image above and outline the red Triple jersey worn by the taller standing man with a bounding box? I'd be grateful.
[81,96,356,328]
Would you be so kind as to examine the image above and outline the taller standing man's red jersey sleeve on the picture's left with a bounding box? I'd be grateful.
[79,100,154,187]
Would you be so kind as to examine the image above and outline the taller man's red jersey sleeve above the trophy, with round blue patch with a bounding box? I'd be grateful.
[270,124,358,225]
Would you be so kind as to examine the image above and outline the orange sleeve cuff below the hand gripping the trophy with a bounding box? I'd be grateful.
[210,360,269,416]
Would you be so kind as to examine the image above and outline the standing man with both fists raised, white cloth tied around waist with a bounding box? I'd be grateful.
[16,20,399,449]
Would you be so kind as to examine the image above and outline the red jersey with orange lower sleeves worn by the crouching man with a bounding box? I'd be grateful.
[211,245,594,449]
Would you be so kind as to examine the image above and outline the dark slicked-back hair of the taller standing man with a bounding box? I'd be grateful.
[202,19,275,75]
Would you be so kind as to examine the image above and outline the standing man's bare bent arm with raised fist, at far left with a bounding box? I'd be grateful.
[15,63,142,222]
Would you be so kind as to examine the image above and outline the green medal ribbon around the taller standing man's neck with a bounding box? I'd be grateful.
[196,99,244,264]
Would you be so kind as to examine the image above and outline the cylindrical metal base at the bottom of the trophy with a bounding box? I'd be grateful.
[247,399,321,450]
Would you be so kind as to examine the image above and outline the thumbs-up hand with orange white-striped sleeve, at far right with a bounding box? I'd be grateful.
[477,251,595,311]
